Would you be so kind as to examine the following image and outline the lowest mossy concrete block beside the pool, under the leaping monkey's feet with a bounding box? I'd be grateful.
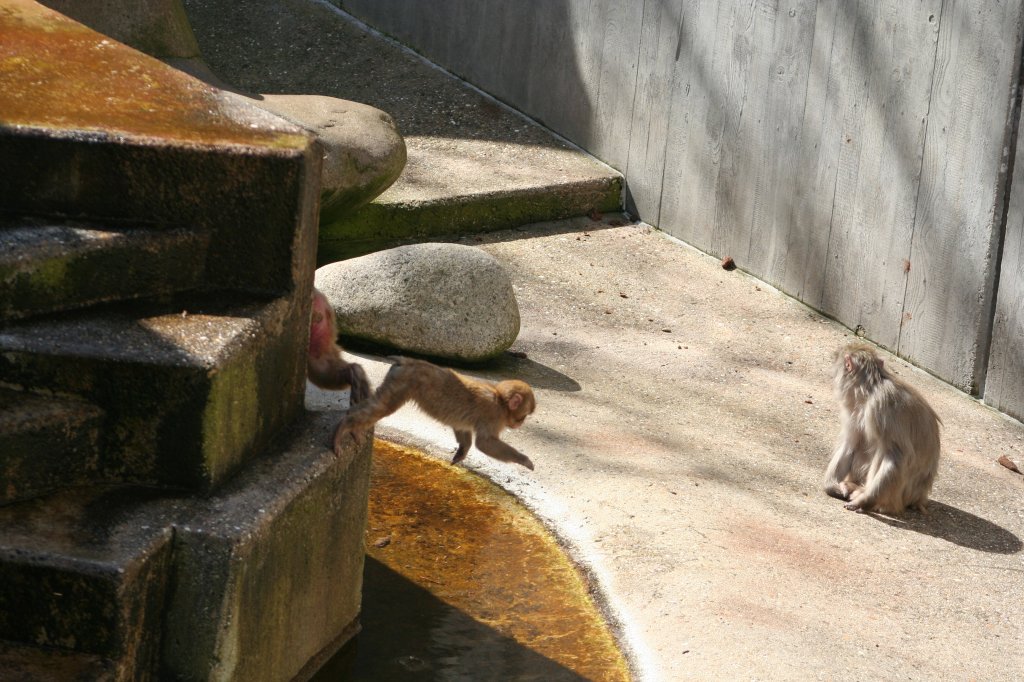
[162,413,371,680]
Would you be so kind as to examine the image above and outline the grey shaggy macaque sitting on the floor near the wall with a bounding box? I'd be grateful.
[825,343,940,514]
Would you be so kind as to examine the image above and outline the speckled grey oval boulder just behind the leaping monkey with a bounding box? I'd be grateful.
[315,244,519,361]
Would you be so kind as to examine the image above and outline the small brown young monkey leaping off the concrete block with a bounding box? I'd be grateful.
[334,357,537,470]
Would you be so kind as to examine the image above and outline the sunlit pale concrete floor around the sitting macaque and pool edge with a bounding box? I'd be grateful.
[309,219,1024,680]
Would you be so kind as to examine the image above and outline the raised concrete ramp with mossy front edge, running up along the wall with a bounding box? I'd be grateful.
[184,0,623,263]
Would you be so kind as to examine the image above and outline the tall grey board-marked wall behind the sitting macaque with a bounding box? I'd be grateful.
[335,0,1024,417]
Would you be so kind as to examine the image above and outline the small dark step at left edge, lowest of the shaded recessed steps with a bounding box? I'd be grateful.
[0,389,103,505]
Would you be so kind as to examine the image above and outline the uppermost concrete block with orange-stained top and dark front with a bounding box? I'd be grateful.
[0,0,322,294]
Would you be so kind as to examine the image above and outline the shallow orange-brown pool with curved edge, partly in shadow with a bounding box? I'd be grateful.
[313,440,629,682]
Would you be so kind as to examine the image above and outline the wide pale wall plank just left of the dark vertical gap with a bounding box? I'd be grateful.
[898,0,1021,392]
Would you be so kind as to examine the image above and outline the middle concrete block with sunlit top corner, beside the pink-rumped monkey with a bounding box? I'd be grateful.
[0,296,307,491]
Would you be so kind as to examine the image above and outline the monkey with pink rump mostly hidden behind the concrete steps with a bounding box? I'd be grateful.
[306,289,370,404]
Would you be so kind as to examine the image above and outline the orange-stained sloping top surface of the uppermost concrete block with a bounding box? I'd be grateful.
[0,0,307,147]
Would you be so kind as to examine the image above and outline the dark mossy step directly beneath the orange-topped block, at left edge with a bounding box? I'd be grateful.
[0,218,210,319]
